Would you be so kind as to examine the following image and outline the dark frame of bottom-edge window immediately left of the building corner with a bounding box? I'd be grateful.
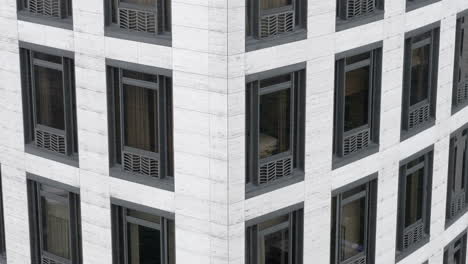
[111,197,176,264]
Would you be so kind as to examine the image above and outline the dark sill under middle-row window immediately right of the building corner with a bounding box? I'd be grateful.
[245,170,304,199]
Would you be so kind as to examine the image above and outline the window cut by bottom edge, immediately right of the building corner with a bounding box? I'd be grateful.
[245,206,304,264]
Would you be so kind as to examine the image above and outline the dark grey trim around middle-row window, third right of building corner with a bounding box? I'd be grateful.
[400,21,440,141]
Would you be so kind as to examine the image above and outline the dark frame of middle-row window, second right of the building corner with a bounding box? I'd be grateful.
[332,42,383,169]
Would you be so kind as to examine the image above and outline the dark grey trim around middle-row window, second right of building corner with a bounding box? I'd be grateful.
[332,41,383,169]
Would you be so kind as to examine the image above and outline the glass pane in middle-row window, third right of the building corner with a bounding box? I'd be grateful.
[410,45,430,105]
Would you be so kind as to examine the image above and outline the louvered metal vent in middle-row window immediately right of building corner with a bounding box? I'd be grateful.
[258,156,292,184]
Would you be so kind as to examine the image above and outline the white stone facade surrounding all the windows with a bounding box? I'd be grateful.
[0,0,468,264]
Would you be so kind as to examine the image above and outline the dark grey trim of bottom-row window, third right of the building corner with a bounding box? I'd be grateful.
[395,145,434,262]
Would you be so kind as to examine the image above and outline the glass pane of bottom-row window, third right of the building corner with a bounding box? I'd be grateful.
[405,168,424,227]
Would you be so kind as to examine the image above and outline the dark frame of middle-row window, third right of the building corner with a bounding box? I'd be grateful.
[400,22,440,141]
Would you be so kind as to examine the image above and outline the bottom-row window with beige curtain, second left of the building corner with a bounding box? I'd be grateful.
[28,177,82,264]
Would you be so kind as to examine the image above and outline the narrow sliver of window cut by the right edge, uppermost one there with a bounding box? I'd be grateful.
[452,14,468,110]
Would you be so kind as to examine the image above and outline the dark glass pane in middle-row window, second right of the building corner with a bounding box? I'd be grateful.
[344,66,370,131]
